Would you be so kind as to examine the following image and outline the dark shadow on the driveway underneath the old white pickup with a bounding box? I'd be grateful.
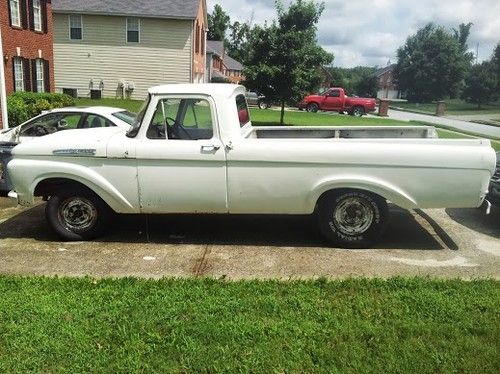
[0,205,456,250]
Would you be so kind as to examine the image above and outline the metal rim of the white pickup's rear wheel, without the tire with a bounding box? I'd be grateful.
[333,197,374,235]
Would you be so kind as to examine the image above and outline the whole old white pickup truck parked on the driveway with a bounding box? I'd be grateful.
[8,84,496,247]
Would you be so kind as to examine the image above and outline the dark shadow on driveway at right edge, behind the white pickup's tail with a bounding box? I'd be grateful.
[446,206,500,238]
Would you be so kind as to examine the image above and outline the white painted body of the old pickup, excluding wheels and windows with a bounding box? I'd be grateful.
[8,84,496,218]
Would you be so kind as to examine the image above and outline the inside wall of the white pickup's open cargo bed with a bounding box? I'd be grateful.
[244,126,437,139]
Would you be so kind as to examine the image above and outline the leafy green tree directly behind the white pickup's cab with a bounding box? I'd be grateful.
[243,0,333,125]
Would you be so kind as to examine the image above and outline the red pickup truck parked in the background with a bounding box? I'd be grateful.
[297,87,375,117]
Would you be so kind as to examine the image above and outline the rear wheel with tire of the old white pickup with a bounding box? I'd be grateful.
[316,190,388,248]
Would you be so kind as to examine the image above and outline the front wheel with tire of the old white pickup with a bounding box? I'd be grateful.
[45,188,110,241]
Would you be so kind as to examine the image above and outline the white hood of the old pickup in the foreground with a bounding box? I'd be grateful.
[12,127,124,157]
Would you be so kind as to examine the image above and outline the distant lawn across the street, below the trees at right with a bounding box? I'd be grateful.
[391,99,500,115]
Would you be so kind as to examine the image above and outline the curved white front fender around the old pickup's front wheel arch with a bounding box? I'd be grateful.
[8,159,139,213]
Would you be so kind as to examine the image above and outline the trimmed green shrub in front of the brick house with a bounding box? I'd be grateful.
[7,92,75,127]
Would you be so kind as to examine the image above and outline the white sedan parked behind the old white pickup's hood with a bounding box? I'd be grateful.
[0,106,135,196]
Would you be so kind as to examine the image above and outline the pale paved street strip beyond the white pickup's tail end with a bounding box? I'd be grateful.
[380,109,500,138]
